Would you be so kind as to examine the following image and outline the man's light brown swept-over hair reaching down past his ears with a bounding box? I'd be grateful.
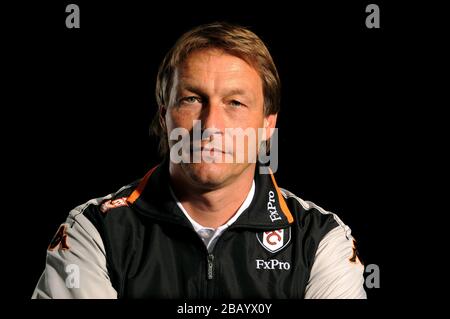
[151,22,281,156]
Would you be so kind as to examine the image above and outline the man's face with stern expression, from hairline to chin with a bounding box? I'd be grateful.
[165,49,276,189]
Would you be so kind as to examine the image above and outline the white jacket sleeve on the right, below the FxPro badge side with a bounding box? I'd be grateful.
[305,225,367,299]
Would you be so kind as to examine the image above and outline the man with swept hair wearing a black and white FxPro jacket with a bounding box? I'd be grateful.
[33,23,366,298]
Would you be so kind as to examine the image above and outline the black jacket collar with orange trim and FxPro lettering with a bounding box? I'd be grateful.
[127,158,294,230]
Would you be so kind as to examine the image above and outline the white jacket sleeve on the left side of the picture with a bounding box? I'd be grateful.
[32,210,117,299]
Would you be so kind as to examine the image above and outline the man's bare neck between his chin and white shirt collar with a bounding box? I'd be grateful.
[171,166,255,228]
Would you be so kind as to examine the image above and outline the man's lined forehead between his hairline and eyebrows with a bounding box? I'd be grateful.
[177,49,262,90]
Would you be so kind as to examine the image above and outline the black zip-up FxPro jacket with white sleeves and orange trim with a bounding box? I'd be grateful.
[33,161,366,299]
